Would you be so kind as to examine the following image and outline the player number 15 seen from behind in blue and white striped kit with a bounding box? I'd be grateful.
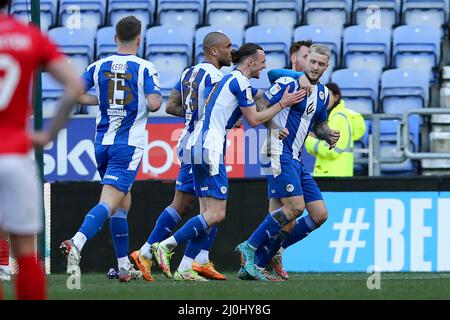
[61,16,162,282]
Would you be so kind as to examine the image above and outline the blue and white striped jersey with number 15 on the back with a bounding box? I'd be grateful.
[83,54,160,148]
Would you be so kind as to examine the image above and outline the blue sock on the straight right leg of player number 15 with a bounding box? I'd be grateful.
[109,208,129,259]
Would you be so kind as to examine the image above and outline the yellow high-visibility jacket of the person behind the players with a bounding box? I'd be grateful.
[305,100,365,177]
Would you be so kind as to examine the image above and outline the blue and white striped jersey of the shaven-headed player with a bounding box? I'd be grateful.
[175,62,223,154]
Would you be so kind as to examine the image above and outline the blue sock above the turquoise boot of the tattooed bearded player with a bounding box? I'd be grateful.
[247,208,289,249]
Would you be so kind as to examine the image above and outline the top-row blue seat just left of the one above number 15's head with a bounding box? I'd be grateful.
[59,0,106,29]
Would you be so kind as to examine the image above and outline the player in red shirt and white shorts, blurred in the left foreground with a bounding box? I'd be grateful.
[0,0,83,299]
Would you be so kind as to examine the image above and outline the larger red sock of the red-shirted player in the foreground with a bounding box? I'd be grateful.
[16,255,47,300]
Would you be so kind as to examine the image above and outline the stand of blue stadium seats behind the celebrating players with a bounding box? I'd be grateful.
[20,0,450,174]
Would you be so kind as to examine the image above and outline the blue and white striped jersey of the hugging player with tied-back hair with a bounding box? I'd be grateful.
[189,70,258,154]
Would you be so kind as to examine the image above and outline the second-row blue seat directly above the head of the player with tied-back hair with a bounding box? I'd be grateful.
[245,26,292,69]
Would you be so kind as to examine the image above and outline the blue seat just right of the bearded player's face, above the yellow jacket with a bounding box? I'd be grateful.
[332,69,379,114]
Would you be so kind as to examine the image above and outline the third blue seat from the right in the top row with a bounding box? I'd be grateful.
[304,0,352,28]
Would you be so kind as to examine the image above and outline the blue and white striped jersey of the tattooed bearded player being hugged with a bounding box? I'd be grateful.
[263,77,329,160]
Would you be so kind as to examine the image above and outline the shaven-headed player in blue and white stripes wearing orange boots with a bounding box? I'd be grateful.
[131,32,231,281]
